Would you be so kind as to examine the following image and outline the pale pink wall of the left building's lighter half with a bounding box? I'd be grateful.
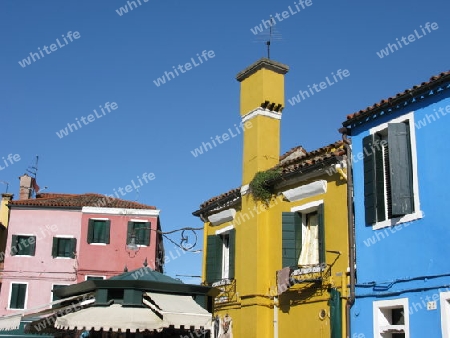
[0,208,81,315]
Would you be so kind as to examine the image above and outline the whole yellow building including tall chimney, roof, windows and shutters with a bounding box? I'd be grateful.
[193,58,349,338]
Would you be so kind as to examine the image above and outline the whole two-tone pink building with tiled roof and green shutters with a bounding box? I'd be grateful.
[0,176,164,315]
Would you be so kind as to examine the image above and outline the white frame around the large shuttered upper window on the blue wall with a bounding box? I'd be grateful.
[368,112,423,230]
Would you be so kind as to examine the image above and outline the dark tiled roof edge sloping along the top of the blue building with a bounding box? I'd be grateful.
[343,71,450,126]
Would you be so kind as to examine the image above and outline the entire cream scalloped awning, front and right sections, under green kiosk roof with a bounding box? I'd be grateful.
[55,292,212,332]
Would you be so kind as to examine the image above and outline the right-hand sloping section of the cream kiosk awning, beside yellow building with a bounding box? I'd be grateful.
[144,292,212,329]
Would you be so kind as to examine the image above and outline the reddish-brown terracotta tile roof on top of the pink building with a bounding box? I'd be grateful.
[9,193,156,210]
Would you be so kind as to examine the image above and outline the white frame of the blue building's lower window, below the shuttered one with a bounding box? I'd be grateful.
[373,298,410,338]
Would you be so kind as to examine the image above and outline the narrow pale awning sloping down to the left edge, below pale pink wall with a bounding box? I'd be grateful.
[0,293,93,331]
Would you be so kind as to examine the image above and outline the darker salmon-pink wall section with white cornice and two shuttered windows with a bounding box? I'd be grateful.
[78,208,160,282]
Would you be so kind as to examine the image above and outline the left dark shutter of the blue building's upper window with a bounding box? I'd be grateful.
[363,135,377,224]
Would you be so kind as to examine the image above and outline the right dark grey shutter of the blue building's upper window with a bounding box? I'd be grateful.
[388,123,414,216]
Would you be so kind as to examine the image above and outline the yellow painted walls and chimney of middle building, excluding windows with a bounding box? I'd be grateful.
[194,60,348,338]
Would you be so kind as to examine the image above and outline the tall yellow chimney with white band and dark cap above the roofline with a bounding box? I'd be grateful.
[236,58,289,185]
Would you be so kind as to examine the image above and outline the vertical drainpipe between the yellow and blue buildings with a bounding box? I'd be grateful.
[339,128,356,338]
